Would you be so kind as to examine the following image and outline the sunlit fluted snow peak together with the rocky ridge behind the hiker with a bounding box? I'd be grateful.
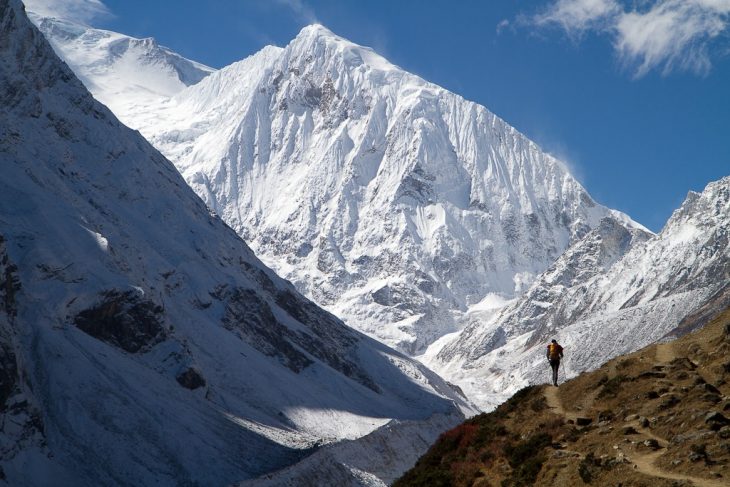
[29,10,730,420]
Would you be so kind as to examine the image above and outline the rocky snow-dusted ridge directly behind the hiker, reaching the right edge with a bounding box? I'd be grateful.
[424,177,730,407]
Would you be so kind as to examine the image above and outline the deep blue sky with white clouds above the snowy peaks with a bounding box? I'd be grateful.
[26,0,730,231]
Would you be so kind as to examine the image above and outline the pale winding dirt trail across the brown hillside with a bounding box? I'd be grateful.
[544,372,727,487]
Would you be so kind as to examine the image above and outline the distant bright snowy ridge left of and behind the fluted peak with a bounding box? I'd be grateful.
[29,12,214,123]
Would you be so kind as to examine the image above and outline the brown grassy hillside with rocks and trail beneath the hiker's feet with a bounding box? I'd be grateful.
[394,309,730,487]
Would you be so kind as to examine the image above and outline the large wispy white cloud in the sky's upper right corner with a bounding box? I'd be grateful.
[522,0,730,78]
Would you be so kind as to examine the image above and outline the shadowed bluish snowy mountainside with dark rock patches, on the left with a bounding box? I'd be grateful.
[0,0,468,486]
